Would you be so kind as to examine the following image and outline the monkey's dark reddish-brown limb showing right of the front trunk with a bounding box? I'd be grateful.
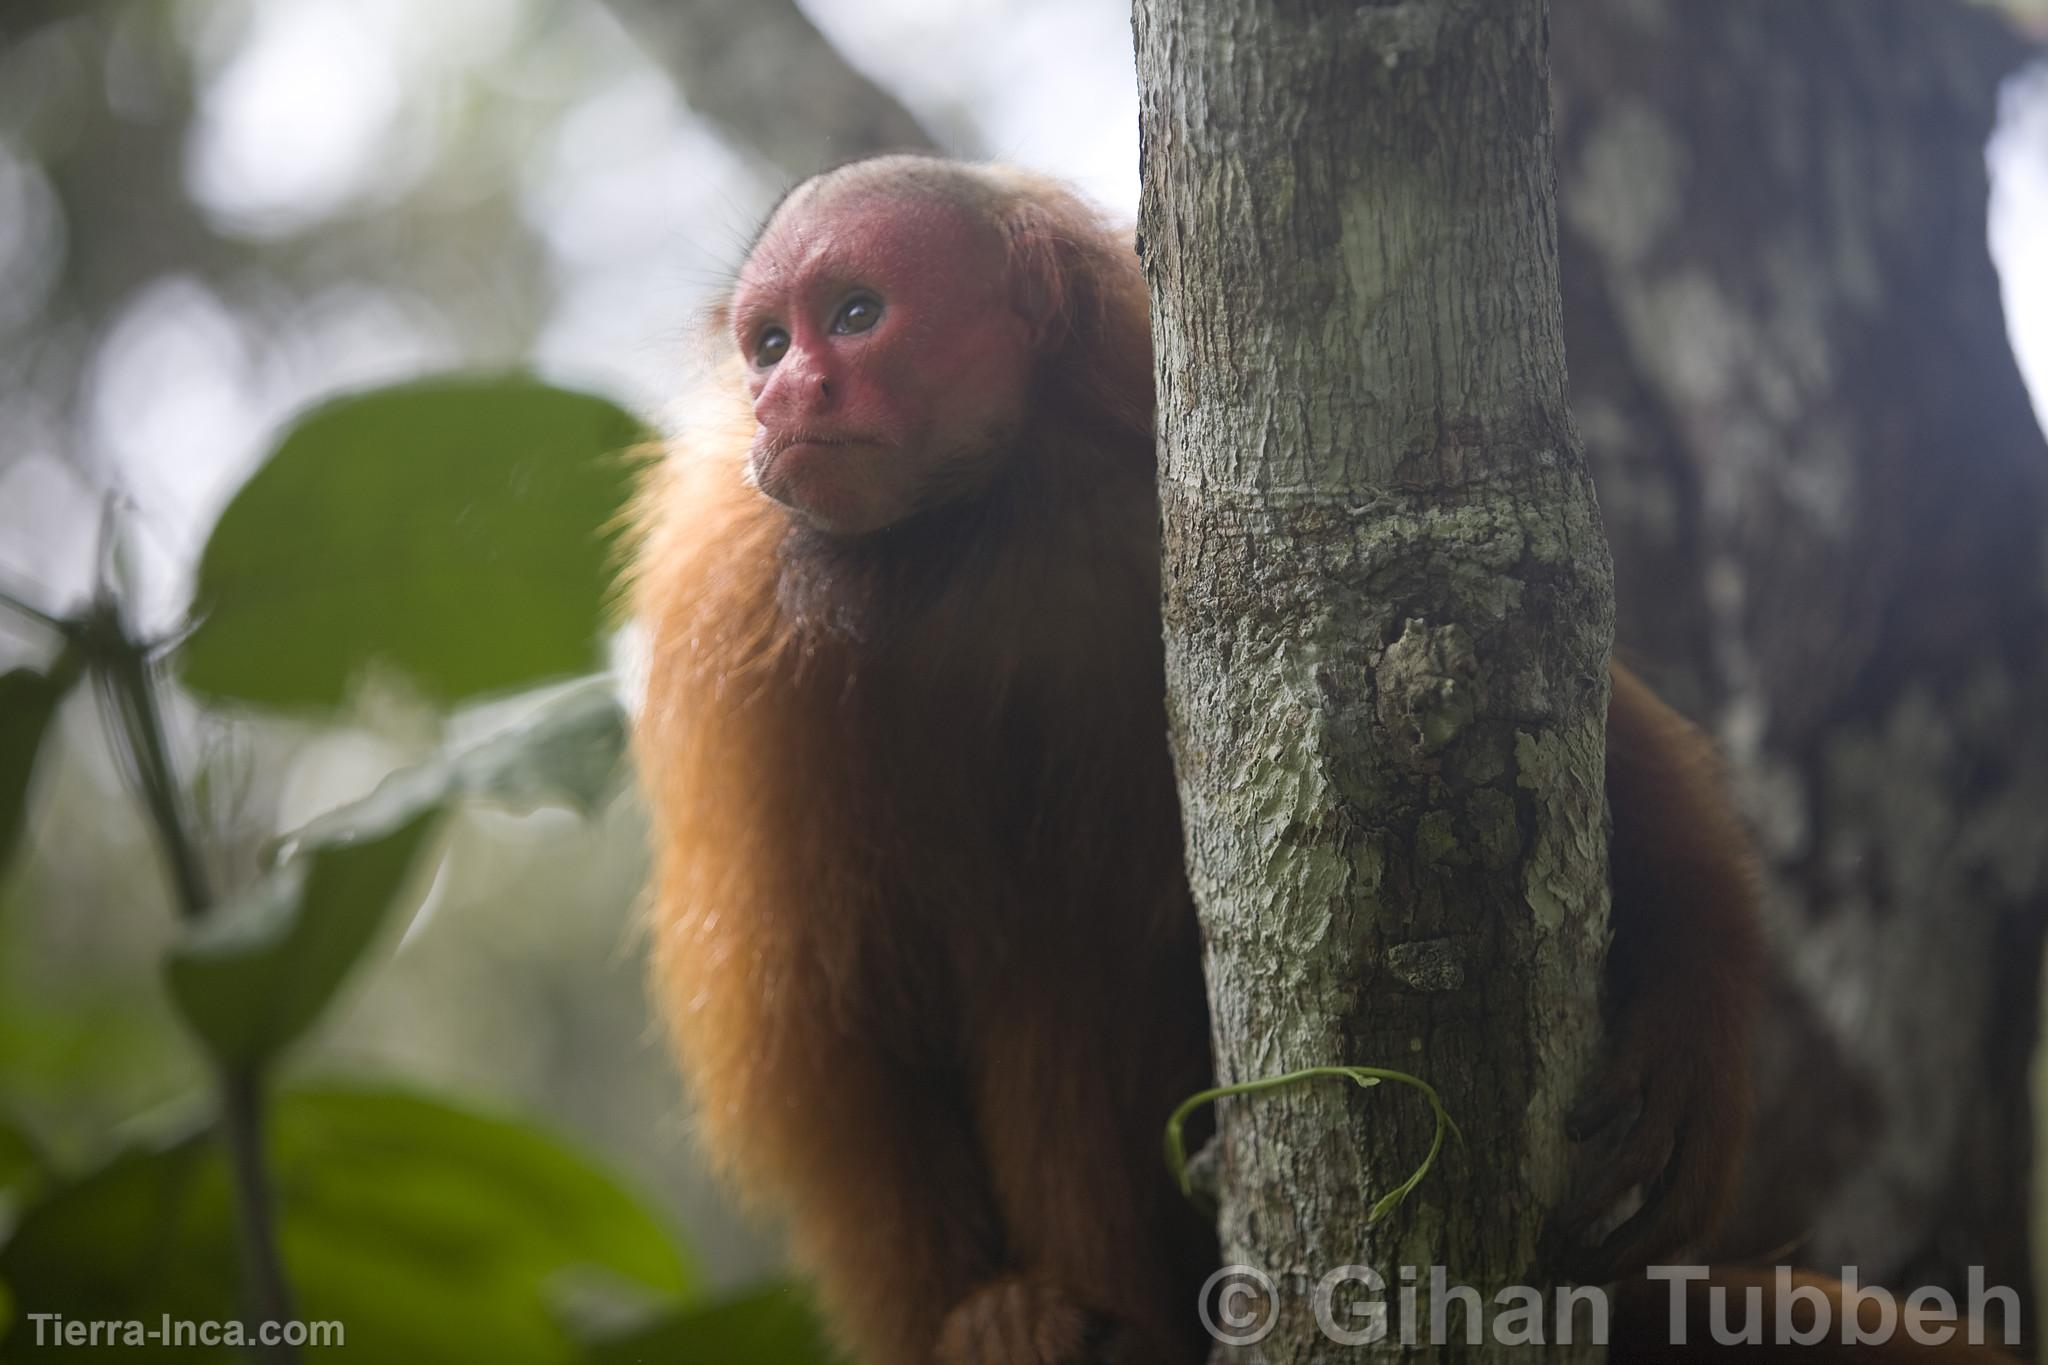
[1556,665,1763,1281]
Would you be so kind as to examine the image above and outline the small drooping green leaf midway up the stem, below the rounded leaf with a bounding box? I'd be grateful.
[166,804,438,1066]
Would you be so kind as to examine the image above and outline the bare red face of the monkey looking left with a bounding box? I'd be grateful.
[731,186,1032,534]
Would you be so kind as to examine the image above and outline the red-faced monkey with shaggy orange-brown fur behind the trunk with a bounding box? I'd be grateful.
[633,158,1998,1365]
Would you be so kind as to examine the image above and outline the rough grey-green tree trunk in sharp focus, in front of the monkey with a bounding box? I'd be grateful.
[1137,0,1612,1361]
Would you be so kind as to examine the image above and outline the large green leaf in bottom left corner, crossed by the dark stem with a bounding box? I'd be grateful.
[0,1089,692,1365]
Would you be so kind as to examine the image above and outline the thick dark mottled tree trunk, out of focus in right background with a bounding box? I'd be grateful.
[1554,0,2048,1326]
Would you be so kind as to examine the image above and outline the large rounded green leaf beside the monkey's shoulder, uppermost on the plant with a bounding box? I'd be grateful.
[180,377,643,706]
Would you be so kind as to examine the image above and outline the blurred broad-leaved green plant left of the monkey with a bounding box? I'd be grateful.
[0,377,825,1365]
